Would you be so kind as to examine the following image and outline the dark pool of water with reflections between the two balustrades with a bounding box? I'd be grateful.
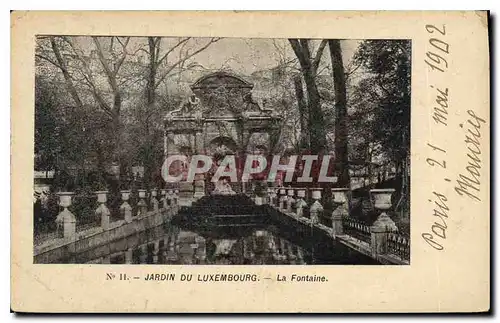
[80,218,374,265]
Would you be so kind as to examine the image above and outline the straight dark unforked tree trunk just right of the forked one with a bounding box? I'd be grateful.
[328,40,350,187]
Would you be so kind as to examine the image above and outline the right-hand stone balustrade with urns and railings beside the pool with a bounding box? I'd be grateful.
[268,187,410,263]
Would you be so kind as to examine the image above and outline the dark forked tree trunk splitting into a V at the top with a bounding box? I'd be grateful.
[289,39,327,154]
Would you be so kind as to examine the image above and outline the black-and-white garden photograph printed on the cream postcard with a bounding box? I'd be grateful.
[33,35,412,265]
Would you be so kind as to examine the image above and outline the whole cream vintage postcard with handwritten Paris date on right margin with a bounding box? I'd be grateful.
[11,11,490,313]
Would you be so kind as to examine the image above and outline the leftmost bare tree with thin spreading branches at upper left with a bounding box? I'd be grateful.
[37,36,135,180]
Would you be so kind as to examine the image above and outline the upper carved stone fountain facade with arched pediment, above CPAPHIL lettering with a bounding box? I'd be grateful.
[164,72,281,161]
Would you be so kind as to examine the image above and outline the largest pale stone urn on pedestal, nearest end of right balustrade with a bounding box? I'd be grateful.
[370,189,398,256]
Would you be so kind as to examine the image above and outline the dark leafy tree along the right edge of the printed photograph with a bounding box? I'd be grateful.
[354,40,411,213]
